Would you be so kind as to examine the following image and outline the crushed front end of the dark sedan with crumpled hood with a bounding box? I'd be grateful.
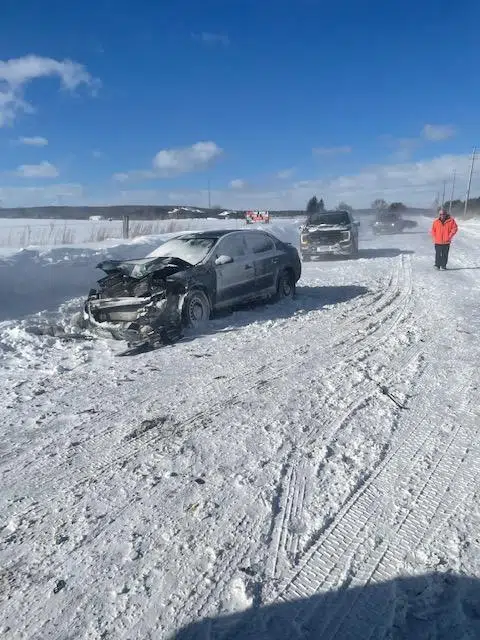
[83,258,192,346]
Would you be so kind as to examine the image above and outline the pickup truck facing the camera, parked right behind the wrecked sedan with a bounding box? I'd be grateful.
[300,211,360,261]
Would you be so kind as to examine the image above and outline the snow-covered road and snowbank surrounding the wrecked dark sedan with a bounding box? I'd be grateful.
[0,219,480,640]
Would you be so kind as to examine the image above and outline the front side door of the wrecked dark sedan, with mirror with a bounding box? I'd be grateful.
[212,231,255,307]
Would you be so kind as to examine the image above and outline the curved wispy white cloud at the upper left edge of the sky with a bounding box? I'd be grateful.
[0,55,100,127]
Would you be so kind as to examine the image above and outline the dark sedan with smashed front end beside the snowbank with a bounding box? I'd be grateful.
[84,230,301,346]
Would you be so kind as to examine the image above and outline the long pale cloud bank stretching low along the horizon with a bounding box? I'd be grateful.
[0,154,472,209]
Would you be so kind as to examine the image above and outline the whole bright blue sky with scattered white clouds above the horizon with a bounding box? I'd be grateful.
[0,0,480,208]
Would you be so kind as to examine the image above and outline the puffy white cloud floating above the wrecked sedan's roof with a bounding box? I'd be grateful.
[113,141,223,182]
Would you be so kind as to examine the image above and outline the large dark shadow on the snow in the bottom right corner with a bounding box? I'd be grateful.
[172,573,480,640]
